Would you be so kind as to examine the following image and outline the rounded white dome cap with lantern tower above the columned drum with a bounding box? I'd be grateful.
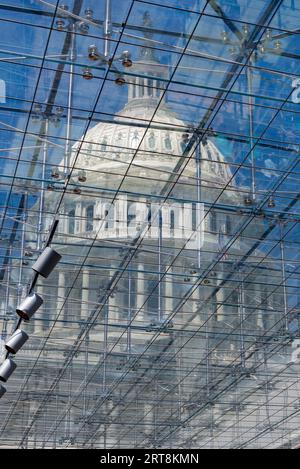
[66,49,232,192]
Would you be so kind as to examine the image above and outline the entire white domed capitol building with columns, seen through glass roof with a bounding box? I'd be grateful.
[4,44,284,448]
